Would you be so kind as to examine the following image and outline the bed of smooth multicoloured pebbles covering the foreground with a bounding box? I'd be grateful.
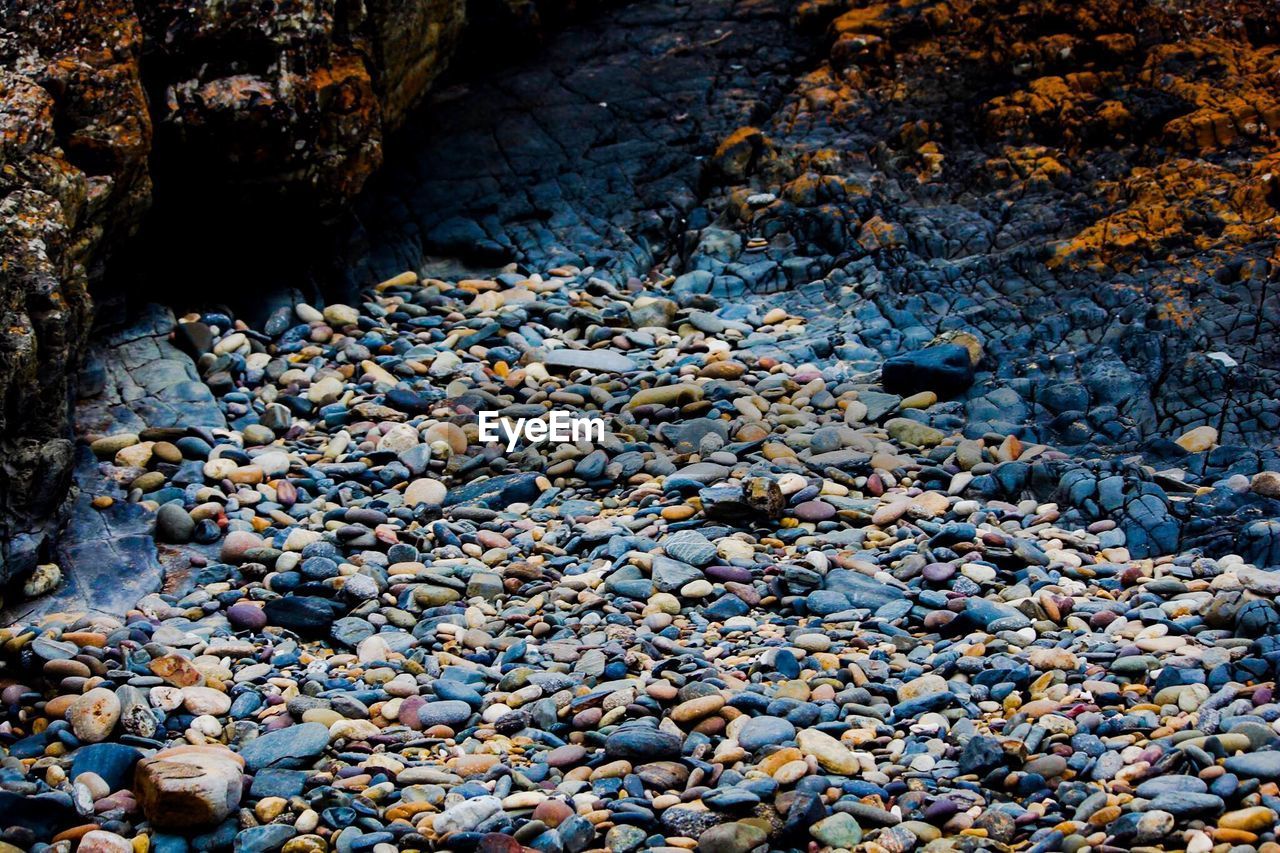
[0,268,1280,853]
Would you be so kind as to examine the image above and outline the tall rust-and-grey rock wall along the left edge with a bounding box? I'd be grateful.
[0,0,151,580]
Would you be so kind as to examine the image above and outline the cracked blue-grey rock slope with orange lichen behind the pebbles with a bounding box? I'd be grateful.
[348,0,1280,555]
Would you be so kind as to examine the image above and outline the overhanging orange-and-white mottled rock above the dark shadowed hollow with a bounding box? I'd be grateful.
[138,0,465,205]
